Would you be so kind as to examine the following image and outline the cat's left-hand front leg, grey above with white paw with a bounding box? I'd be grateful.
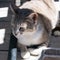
[19,44,30,59]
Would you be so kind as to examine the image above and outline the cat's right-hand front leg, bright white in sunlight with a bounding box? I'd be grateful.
[29,46,47,56]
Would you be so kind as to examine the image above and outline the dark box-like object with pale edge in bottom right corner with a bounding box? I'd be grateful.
[42,49,60,60]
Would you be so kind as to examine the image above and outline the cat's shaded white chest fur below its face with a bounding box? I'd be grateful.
[17,30,43,45]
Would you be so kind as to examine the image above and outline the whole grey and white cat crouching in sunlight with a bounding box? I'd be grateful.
[11,0,57,58]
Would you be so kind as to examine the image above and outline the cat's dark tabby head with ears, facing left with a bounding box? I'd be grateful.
[11,9,38,35]
